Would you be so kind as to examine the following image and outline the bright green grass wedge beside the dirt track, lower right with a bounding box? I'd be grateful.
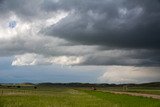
[84,90,160,107]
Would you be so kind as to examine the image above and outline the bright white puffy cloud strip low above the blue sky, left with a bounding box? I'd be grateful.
[12,53,82,66]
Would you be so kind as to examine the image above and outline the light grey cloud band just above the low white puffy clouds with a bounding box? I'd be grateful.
[0,36,72,57]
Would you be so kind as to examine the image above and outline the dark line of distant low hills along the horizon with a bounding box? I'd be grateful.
[0,82,160,88]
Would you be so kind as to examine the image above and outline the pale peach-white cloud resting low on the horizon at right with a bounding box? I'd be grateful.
[98,66,160,84]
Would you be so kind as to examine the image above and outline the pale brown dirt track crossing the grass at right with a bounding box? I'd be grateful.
[109,91,160,99]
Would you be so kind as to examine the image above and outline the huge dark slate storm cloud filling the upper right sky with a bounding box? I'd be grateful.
[44,0,160,49]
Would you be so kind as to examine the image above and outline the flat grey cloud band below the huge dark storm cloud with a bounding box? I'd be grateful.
[81,50,160,67]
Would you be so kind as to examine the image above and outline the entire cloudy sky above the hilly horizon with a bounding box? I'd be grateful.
[0,0,160,84]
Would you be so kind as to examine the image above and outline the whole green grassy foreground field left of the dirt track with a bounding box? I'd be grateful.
[0,87,160,107]
